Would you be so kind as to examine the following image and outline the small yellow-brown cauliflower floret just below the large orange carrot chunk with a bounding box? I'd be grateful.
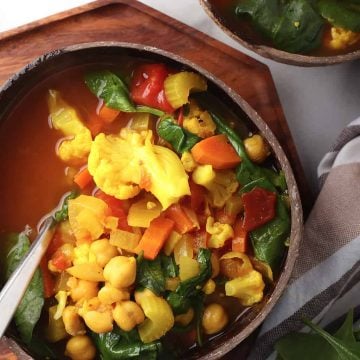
[192,165,239,208]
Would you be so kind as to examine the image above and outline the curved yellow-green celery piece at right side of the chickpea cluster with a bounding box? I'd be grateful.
[138,296,174,343]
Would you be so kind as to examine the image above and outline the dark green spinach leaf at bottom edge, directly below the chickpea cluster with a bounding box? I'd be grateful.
[91,327,162,360]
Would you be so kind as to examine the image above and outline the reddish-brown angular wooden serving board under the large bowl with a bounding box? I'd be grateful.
[0,0,312,359]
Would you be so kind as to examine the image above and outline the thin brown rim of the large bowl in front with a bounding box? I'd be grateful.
[0,41,303,360]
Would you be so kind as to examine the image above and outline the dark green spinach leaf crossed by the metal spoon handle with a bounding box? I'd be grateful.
[5,233,44,344]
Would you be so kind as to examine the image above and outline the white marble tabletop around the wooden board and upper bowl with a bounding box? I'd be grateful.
[0,0,360,190]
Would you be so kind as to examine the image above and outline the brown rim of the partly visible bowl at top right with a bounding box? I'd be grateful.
[199,0,360,67]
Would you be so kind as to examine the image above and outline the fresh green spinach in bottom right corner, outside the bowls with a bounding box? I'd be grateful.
[275,311,360,360]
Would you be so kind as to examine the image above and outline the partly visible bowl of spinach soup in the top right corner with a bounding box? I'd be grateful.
[200,0,360,66]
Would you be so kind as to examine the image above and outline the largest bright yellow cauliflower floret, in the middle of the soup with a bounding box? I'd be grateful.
[88,129,190,209]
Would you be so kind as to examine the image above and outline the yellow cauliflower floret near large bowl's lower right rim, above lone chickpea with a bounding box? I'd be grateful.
[225,270,265,306]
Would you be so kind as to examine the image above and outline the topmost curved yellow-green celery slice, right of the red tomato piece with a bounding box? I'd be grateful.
[164,71,207,109]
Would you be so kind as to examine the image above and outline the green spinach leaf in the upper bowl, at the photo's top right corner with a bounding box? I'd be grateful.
[318,0,360,32]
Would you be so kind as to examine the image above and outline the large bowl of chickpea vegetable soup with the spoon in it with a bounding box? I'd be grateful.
[0,42,302,360]
